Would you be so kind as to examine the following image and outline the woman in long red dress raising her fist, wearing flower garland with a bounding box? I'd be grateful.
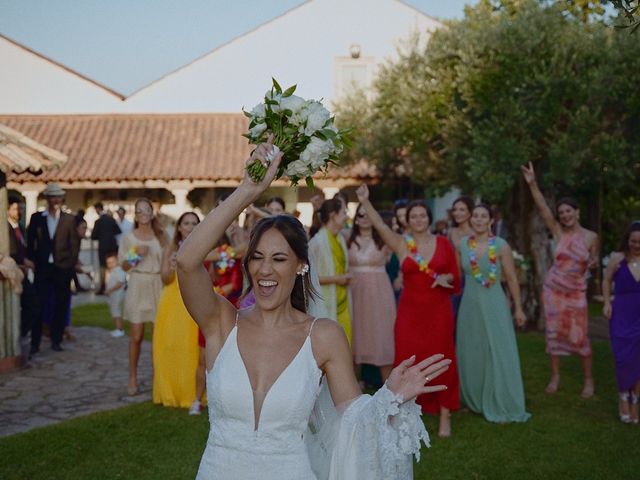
[356,185,460,437]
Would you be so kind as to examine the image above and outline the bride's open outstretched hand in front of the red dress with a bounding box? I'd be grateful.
[387,353,451,402]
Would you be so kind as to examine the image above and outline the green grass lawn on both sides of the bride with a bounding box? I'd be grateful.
[0,306,640,480]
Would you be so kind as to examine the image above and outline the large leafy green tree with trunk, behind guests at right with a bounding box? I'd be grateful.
[339,0,640,324]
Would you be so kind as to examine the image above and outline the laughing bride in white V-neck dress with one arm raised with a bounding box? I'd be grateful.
[177,139,450,480]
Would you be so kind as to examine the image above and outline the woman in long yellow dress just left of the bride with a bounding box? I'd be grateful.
[153,212,200,408]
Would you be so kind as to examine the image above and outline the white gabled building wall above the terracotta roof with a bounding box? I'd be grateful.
[0,0,440,113]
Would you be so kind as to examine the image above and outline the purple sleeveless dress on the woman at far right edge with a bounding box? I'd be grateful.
[609,260,640,392]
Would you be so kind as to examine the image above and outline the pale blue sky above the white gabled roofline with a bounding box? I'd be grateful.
[0,0,475,95]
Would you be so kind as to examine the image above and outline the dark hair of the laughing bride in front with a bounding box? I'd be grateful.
[242,215,318,313]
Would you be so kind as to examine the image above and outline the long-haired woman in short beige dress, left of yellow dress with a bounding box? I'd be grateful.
[118,198,168,395]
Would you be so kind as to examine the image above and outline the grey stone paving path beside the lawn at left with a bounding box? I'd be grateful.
[0,327,152,437]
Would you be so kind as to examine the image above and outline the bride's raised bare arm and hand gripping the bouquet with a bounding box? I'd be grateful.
[177,137,282,336]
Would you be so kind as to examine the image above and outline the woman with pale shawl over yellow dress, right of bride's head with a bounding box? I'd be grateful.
[309,198,352,342]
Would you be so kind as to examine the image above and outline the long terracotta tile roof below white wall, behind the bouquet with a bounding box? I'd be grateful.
[0,113,375,183]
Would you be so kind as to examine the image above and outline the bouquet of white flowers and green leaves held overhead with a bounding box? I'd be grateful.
[243,79,349,187]
